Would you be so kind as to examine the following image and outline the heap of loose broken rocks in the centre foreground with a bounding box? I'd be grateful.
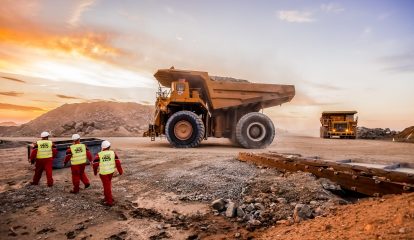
[211,173,347,230]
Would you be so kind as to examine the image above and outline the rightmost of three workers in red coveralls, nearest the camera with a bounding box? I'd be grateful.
[93,141,124,206]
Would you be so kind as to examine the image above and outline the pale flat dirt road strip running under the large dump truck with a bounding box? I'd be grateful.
[104,135,414,164]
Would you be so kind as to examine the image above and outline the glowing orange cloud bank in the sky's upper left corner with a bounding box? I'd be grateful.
[0,0,127,63]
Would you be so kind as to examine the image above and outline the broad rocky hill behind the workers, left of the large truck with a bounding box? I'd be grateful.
[0,102,154,137]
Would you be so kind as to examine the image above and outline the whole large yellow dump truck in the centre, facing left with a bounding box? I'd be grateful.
[144,68,295,148]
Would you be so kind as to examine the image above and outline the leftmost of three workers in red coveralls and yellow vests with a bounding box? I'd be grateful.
[30,132,57,187]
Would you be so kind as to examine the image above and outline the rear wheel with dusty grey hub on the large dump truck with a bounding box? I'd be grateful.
[236,112,275,148]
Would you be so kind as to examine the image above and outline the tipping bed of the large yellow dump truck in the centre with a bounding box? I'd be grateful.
[154,69,295,110]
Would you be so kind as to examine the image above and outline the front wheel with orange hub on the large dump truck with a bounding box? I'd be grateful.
[165,111,205,148]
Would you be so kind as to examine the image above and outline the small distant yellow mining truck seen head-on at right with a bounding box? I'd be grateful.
[320,111,358,139]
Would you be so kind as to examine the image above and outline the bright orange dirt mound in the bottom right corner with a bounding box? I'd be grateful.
[255,193,414,239]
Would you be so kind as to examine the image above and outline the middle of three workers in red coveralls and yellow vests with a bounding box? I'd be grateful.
[64,134,92,194]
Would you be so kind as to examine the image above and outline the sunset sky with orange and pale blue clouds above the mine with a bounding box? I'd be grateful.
[0,0,414,134]
